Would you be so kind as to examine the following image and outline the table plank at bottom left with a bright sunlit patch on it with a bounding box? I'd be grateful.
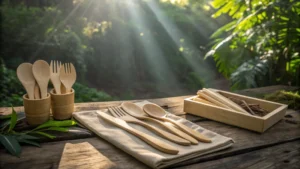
[0,138,147,169]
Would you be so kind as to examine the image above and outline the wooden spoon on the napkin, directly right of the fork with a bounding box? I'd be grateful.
[121,102,198,144]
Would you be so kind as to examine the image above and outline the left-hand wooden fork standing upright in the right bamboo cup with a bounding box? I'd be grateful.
[50,60,61,94]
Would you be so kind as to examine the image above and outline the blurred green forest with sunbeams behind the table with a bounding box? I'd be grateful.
[0,0,300,106]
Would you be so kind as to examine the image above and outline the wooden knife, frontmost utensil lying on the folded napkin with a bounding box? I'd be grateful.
[99,113,179,154]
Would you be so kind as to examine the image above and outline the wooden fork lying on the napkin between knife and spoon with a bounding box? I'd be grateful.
[108,107,191,146]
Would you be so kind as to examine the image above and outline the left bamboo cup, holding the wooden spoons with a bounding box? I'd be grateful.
[23,93,51,126]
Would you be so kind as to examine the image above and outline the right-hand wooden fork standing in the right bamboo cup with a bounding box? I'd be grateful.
[60,63,76,93]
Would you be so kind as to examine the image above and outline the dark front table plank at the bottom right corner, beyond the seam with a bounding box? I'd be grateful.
[173,140,300,169]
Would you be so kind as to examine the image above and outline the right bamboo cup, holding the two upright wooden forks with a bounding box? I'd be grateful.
[50,89,75,120]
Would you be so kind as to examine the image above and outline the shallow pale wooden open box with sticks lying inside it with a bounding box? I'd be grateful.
[184,89,287,133]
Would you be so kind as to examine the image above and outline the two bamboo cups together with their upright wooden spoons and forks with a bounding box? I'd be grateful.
[17,60,76,125]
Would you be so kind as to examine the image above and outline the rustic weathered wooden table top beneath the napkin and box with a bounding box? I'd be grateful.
[0,96,300,169]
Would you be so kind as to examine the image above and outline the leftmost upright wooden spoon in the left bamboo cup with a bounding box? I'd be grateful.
[17,63,35,99]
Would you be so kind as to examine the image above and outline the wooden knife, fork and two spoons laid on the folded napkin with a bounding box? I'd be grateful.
[99,102,211,154]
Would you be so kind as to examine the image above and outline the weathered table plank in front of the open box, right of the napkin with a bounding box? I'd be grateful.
[171,110,300,165]
